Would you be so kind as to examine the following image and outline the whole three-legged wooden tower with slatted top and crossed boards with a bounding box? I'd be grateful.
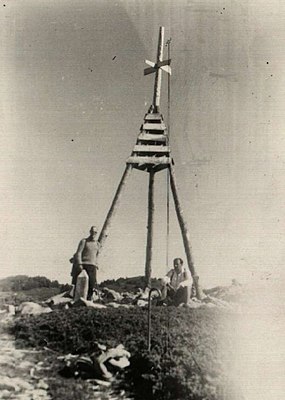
[99,27,201,298]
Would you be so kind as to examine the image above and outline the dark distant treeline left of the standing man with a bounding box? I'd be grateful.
[0,275,70,292]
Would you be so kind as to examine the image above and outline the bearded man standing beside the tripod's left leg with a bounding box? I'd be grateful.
[74,226,101,300]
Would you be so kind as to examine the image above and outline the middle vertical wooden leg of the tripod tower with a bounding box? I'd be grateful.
[145,168,154,287]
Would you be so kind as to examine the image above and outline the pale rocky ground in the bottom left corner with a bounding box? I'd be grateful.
[0,310,133,400]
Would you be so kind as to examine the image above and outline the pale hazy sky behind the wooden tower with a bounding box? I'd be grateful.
[0,0,285,287]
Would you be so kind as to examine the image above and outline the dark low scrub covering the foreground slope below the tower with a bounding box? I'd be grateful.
[11,307,237,400]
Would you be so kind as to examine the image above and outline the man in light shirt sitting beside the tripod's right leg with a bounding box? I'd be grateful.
[161,258,192,306]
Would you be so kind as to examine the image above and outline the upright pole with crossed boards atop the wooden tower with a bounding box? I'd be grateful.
[144,26,171,112]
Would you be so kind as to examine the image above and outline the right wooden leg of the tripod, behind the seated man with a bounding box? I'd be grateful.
[169,165,202,300]
